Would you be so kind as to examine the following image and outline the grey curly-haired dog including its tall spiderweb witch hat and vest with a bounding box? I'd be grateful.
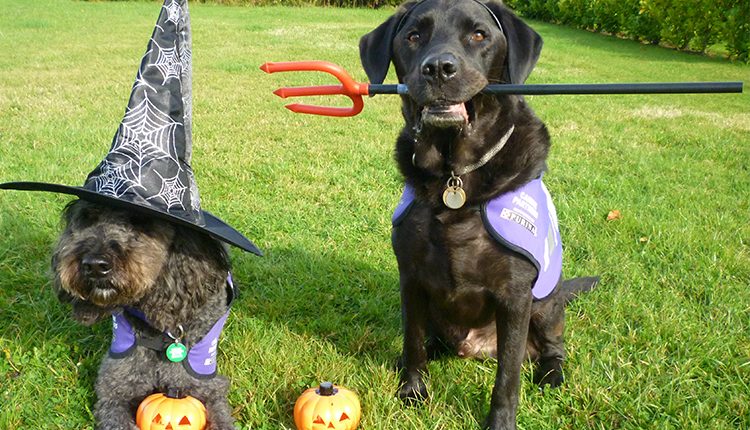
[0,0,262,430]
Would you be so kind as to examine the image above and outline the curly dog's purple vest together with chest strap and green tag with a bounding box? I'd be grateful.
[109,273,236,379]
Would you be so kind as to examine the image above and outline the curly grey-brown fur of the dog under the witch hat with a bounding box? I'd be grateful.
[52,200,234,430]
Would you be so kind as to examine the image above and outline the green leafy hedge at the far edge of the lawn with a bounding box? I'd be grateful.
[505,0,750,62]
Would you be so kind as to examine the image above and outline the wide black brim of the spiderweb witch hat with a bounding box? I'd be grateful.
[0,182,263,256]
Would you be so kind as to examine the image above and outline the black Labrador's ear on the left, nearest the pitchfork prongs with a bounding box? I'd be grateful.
[359,1,418,84]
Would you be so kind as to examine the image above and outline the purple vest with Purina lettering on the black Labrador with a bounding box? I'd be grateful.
[391,178,562,300]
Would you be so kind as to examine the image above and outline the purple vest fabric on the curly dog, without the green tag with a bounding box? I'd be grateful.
[109,273,234,378]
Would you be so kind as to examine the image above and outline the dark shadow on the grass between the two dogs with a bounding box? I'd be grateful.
[234,248,401,363]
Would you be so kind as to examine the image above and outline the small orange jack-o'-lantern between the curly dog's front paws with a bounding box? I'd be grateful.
[135,389,206,430]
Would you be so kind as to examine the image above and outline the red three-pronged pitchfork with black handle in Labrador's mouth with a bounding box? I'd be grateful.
[260,61,742,117]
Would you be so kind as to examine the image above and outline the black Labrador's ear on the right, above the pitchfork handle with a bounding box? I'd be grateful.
[487,2,542,84]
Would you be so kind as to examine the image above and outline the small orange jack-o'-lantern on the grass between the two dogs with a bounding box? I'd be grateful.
[294,382,362,430]
